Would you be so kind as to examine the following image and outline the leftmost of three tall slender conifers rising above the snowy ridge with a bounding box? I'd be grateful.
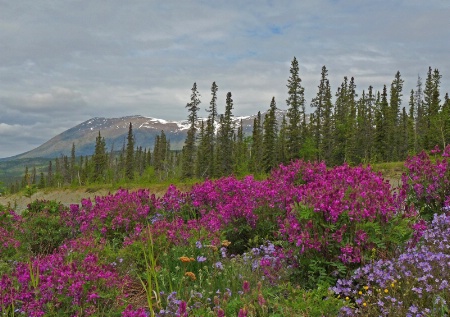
[182,83,200,178]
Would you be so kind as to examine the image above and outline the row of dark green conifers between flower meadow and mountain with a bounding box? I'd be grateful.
[11,57,450,192]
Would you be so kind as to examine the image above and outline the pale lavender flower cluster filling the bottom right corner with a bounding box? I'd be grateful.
[332,214,450,316]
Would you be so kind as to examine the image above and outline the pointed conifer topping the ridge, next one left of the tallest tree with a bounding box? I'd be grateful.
[263,97,278,172]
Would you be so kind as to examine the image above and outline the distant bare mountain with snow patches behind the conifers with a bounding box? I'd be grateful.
[0,110,286,162]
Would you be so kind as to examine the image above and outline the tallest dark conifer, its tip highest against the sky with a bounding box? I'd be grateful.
[286,57,305,159]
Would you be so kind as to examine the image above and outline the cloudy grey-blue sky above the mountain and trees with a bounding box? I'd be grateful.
[0,0,450,158]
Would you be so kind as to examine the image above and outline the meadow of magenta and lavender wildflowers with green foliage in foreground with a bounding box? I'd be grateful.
[0,146,450,317]
